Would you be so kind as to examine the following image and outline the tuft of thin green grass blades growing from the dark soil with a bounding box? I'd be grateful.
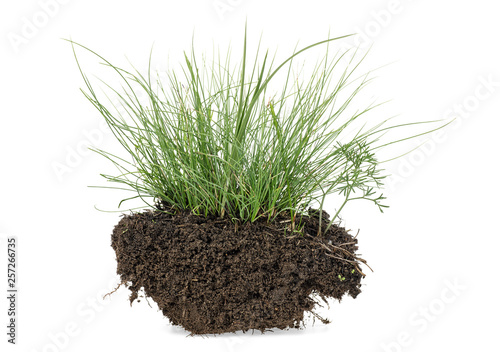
[71,31,444,230]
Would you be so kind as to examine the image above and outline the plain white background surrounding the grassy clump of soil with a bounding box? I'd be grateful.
[0,0,500,352]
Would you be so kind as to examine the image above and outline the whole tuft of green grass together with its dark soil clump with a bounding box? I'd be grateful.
[71,26,441,334]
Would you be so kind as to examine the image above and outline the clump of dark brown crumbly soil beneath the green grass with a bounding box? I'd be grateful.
[112,211,363,334]
